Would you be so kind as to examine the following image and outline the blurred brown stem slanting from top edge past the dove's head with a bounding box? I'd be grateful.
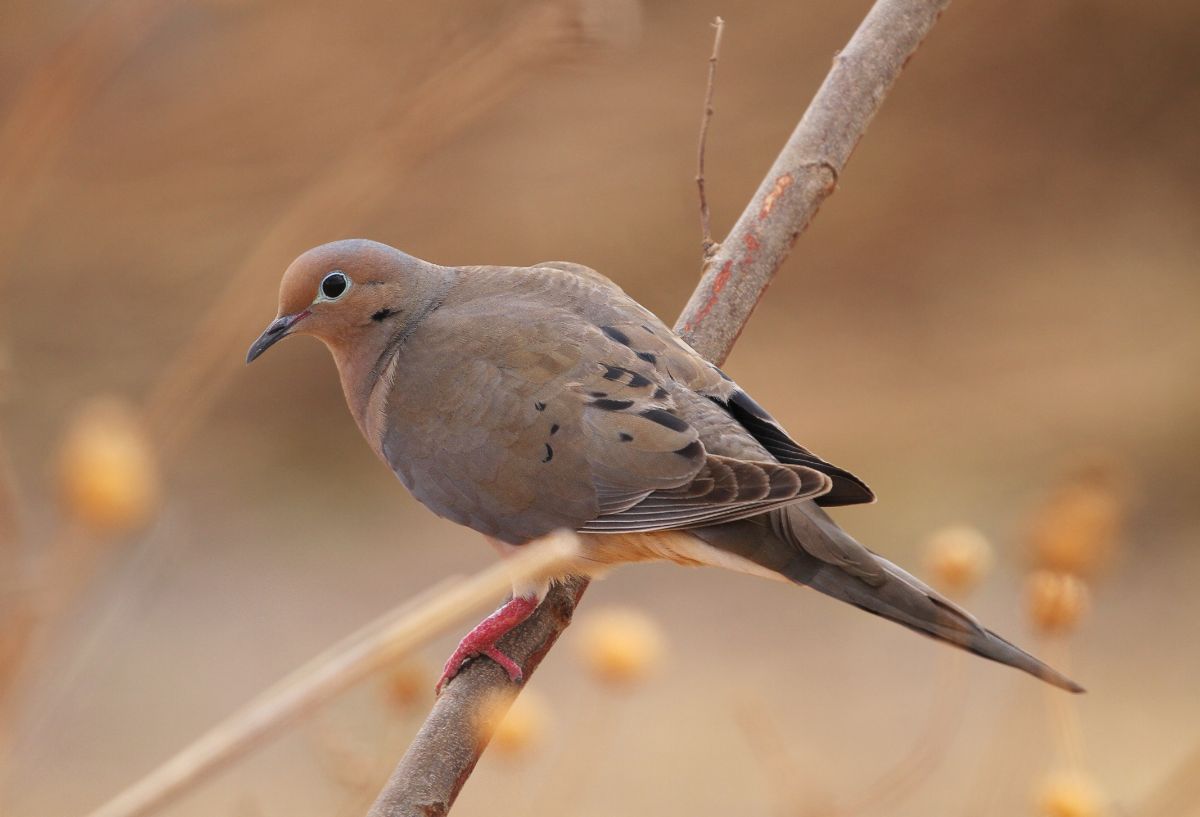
[145,0,600,458]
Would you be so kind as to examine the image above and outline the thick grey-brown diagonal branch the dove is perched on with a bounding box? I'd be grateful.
[370,0,949,817]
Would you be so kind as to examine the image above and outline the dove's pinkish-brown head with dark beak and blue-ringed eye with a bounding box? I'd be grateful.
[246,239,443,364]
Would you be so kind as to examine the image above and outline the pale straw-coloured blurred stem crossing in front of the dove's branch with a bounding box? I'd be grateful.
[78,533,577,817]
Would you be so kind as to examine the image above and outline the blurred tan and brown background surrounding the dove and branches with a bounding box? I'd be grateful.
[0,0,1200,817]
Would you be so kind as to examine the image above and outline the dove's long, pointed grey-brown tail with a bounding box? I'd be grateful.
[692,503,1084,692]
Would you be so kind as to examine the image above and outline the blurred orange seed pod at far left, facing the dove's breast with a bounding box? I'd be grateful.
[59,398,158,535]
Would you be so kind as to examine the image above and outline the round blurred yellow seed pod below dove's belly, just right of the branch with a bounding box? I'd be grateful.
[577,607,664,686]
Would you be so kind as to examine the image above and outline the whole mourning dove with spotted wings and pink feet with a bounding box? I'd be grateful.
[246,240,1081,692]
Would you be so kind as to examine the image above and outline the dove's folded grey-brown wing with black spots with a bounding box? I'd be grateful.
[378,263,859,543]
